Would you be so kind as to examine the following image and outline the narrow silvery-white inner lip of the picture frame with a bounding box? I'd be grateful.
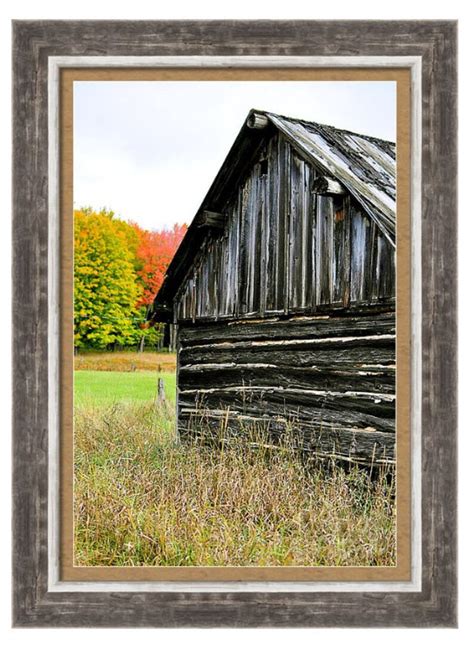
[48,55,422,592]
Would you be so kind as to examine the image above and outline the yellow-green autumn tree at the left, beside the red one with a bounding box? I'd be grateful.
[74,210,141,349]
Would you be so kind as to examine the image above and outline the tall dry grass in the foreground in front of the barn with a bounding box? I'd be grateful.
[75,404,395,566]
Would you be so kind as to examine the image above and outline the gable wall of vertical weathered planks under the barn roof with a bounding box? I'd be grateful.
[175,135,395,321]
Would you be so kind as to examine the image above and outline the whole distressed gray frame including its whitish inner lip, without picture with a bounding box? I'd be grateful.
[13,21,457,627]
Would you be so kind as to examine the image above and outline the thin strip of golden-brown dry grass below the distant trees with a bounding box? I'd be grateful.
[74,351,176,373]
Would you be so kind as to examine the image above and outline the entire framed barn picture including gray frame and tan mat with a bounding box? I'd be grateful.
[13,21,457,627]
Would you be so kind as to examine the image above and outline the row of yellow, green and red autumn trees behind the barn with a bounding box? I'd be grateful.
[74,208,186,349]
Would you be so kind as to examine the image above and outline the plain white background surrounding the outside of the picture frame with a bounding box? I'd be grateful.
[0,0,474,648]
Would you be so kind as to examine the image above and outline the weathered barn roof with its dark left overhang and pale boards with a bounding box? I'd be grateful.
[150,109,396,317]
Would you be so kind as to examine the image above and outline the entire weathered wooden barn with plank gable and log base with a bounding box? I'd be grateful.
[151,110,396,464]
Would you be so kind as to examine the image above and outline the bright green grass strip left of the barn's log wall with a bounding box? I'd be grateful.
[74,371,176,405]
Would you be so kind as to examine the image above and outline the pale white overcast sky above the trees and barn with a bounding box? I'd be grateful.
[74,81,396,229]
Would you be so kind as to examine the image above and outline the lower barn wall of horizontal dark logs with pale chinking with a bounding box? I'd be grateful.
[178,312,395,464]
